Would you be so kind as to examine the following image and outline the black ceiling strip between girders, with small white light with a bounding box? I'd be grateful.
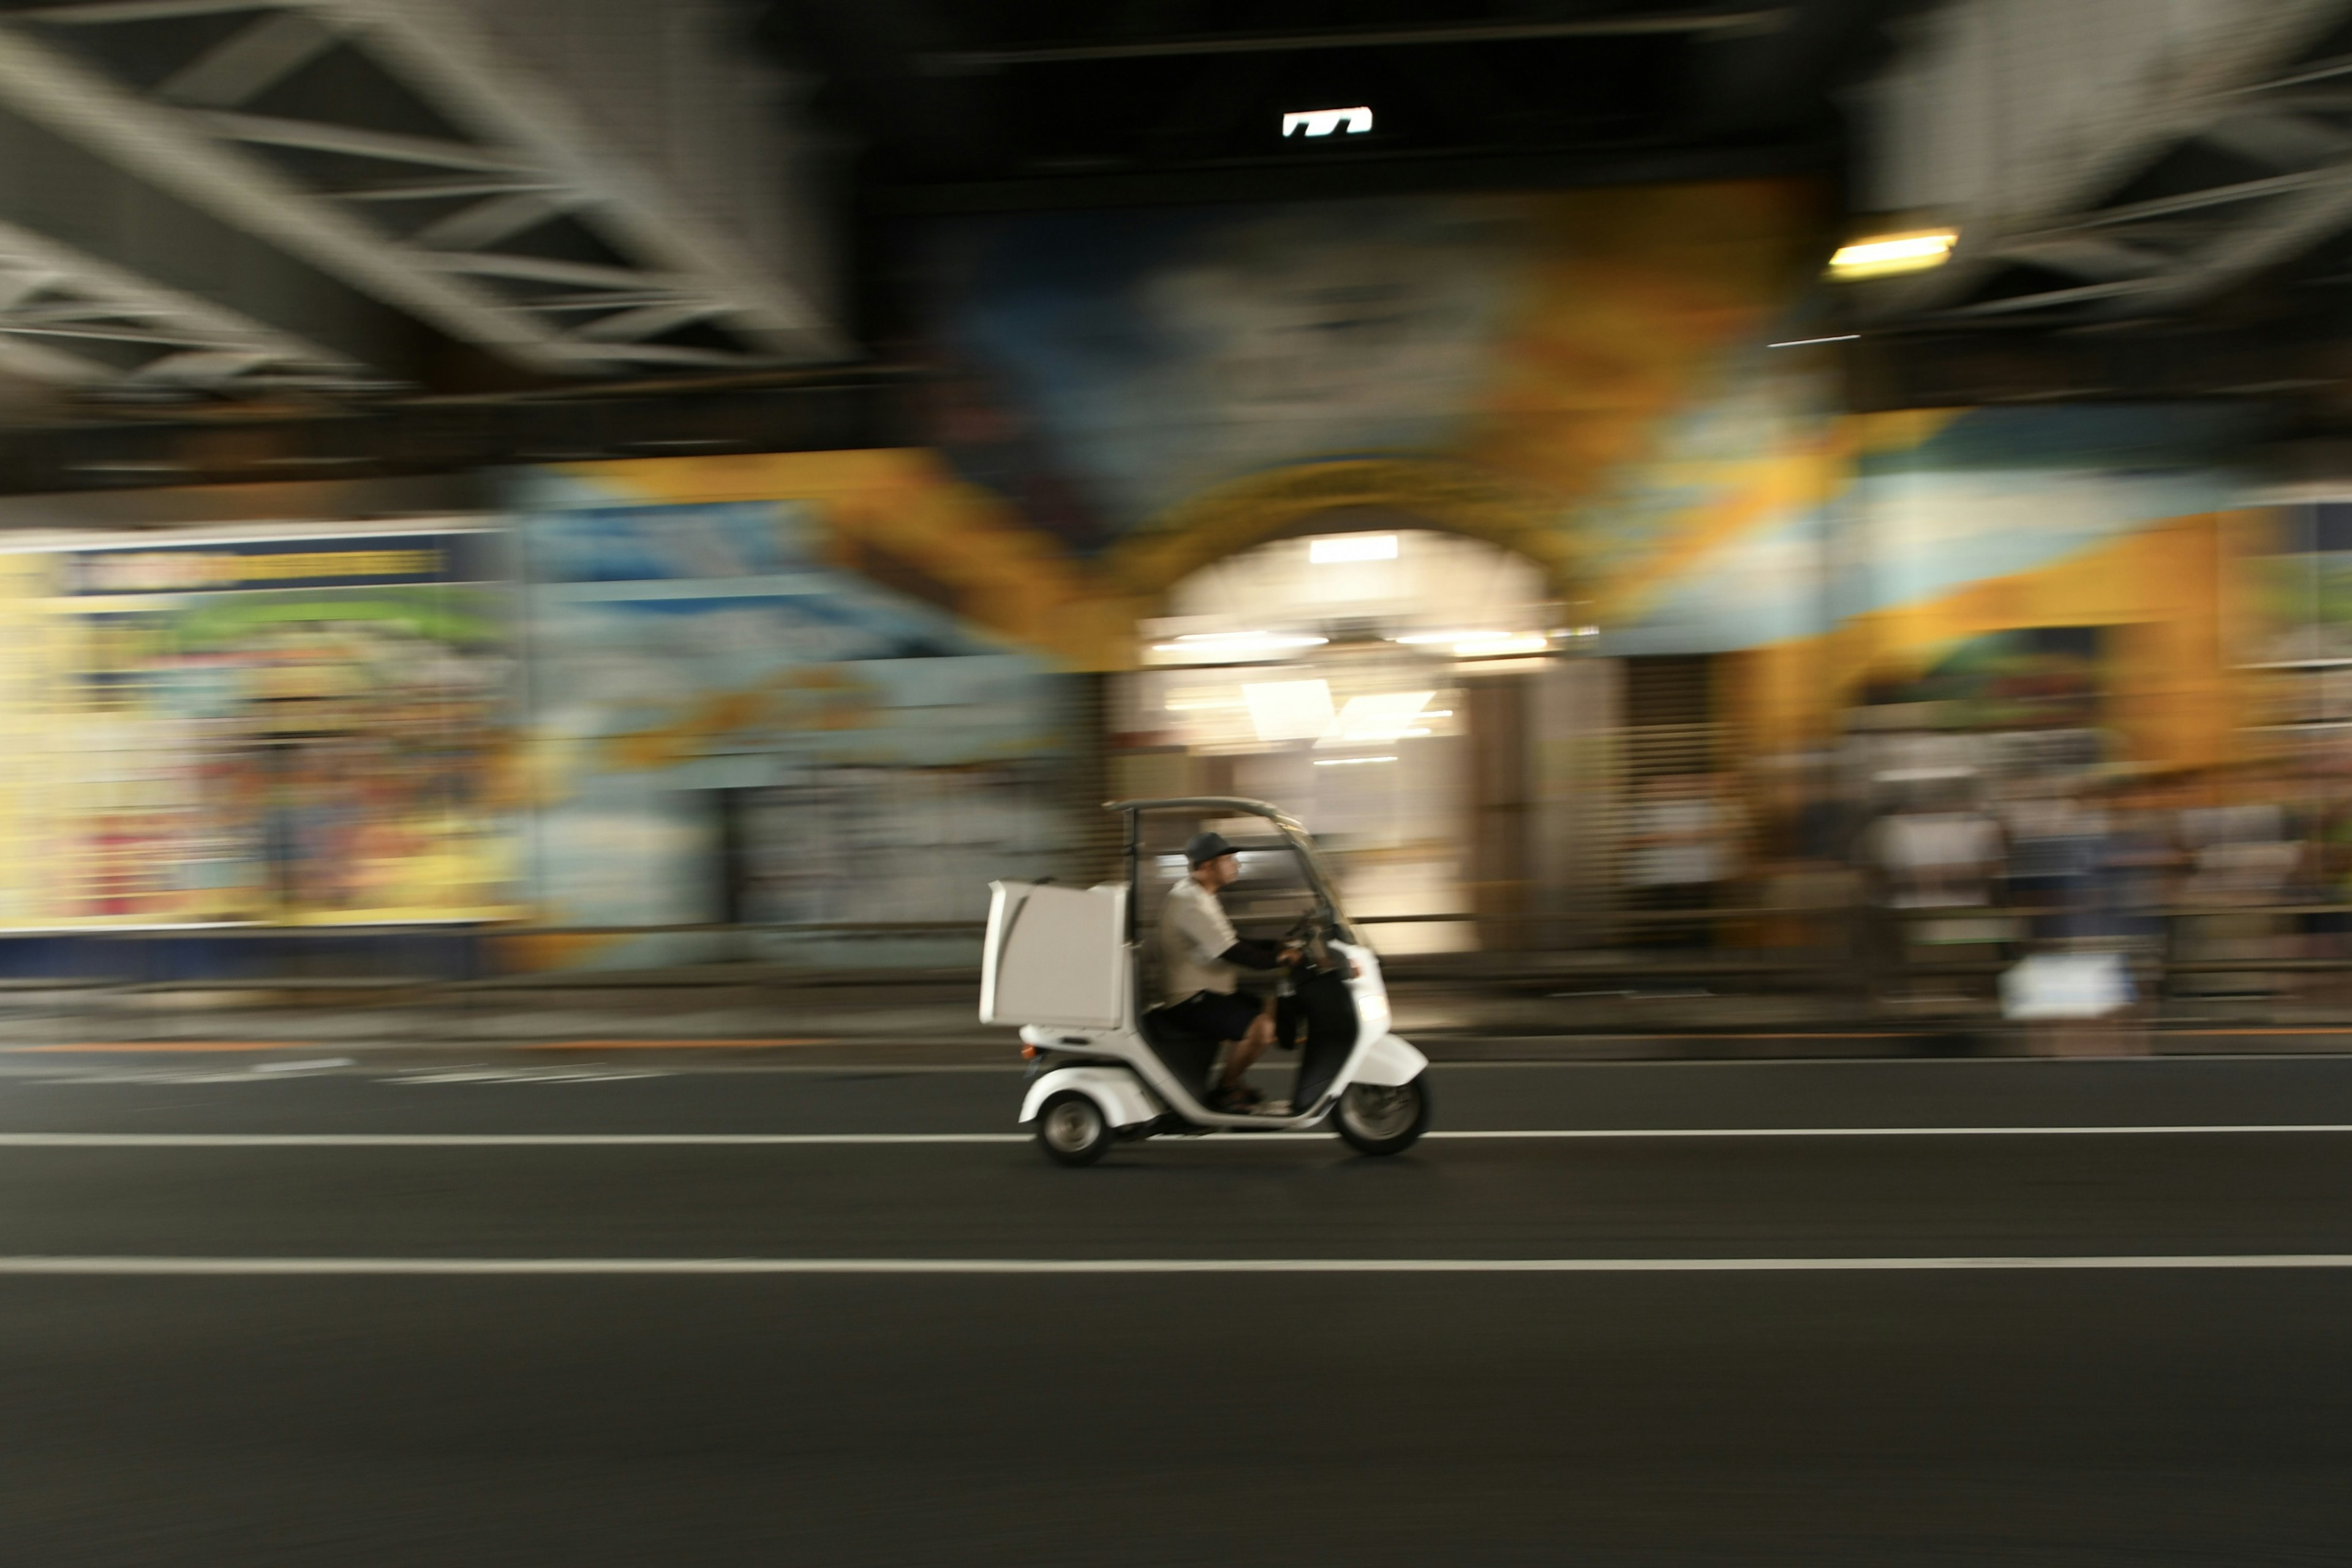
[762,0,1912,211]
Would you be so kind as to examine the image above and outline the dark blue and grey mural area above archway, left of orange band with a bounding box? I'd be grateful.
[932,197,1529,548]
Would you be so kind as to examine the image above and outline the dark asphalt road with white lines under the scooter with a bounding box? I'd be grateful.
[0,1058,2352,1566]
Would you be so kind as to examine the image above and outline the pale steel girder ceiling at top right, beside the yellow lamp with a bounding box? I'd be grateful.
[1849,0,2352,426]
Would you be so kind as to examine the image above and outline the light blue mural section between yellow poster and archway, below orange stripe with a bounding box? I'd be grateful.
[520,475,1068,966]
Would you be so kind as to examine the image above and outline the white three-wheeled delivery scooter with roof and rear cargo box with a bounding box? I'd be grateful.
[981,797,1430,1166]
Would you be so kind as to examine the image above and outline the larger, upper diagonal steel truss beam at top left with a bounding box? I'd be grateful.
[0,0,849,374]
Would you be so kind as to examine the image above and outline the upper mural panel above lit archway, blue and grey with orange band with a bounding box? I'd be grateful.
[932,181,1818,602]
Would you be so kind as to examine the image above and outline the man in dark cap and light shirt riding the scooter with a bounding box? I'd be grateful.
[1159,832,1298,1112]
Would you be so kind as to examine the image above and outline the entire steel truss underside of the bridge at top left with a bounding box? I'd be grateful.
[0,0,851,395]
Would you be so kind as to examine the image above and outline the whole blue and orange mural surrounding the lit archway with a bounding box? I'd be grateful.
[505,181,2244,959]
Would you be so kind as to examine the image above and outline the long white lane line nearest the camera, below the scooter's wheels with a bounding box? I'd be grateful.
[0,1253,2352,1274]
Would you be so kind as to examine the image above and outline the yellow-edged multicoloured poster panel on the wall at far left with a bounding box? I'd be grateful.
[0,524,520,929]
